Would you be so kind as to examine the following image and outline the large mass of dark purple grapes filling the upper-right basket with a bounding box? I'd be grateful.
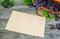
[30,0,60,11]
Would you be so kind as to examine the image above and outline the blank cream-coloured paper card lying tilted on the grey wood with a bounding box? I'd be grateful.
[5,11,45,37]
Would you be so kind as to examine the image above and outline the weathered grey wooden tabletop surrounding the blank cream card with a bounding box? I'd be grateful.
[0,0,60,39]
